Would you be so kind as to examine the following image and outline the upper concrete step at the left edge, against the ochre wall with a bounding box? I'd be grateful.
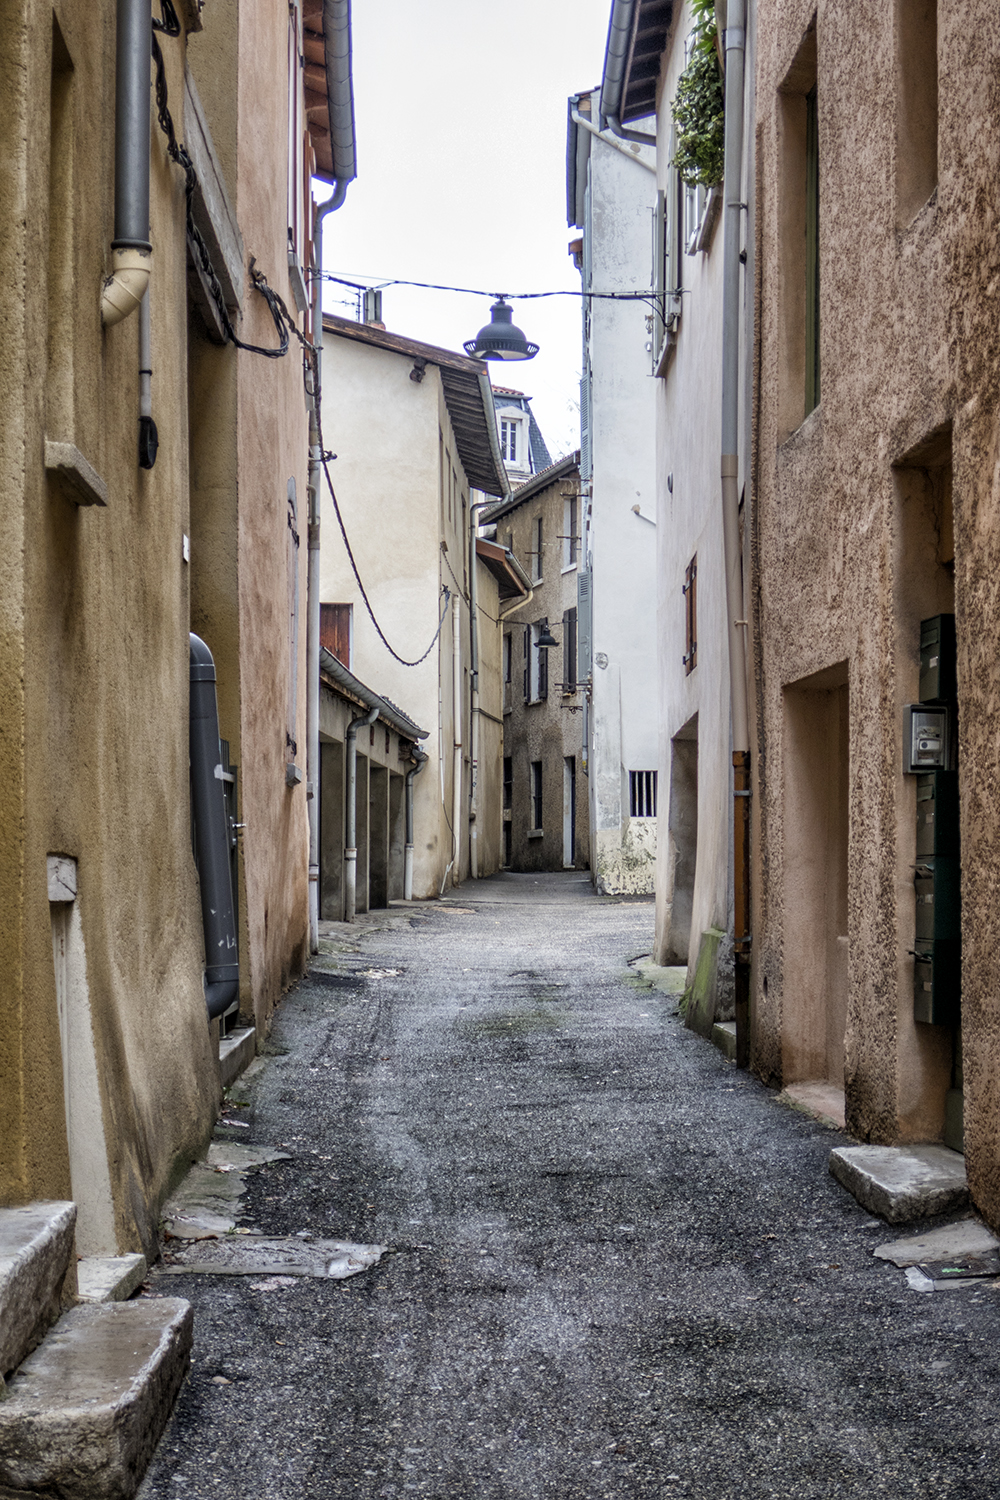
[0,1202,76,1380]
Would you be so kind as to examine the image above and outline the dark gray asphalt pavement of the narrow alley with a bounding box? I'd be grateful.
[141,872,1000,1500]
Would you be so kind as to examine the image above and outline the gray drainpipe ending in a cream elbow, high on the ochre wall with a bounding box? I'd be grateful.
[100,0,153,329]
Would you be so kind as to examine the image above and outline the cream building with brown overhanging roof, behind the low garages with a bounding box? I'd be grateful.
[319,315,528,900]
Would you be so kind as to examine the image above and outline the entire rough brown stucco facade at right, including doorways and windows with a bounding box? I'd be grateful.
[750,0,1000,1223]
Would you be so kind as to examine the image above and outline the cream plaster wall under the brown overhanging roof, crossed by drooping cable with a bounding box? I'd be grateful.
[321,333,499,900]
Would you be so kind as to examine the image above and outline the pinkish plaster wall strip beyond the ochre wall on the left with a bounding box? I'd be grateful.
[237,0,309,1026]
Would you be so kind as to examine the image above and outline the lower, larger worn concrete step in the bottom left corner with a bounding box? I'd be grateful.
[0,1298,193,1500]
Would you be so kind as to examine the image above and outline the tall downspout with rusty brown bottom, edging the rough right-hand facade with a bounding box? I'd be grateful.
[721,0,751,1068]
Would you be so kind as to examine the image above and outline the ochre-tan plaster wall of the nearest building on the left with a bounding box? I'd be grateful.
[0,3,217,1250]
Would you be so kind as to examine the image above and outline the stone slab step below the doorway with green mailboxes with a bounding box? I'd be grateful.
[829,1146,969,1224]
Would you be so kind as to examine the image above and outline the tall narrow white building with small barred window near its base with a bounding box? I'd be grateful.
[567,90,663,894]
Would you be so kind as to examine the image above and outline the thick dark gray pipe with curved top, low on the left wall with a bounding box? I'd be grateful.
[190,635,240,1020]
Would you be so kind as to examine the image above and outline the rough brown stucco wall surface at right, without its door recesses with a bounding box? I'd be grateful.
[753,0,1000,1223]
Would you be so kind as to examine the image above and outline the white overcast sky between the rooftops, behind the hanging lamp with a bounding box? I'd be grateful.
[316,0,610,459]
